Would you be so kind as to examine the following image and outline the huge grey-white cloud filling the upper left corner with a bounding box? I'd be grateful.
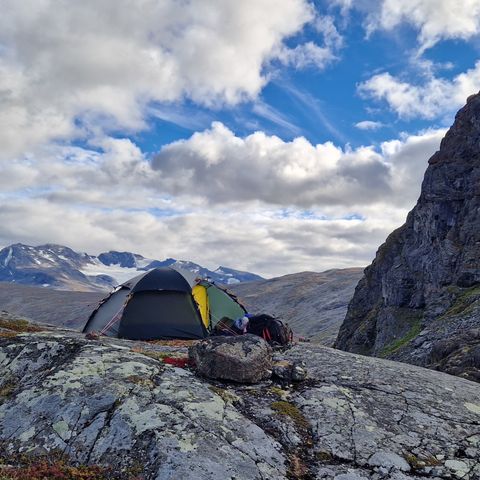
[0,0,315,156]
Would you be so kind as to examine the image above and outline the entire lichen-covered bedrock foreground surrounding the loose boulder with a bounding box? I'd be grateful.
[0,318,480,480]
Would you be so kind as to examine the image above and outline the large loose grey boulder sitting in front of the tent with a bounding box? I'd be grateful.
[188,334,272,383]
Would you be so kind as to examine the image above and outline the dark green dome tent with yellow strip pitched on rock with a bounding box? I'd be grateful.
[83,267,245,340]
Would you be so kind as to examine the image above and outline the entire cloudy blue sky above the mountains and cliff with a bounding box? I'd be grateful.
[0,0,480,277]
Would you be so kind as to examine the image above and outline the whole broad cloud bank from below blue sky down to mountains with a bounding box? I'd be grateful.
[0,124,444,275]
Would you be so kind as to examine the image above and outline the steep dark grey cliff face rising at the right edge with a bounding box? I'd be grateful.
[336,95,480,376]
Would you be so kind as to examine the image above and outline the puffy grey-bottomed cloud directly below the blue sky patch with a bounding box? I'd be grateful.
[152,122,443,207]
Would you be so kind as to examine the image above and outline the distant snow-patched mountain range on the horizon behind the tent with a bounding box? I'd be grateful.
[0,243,263,292]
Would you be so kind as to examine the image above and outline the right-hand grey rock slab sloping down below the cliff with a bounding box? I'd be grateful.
[285,345,480,480]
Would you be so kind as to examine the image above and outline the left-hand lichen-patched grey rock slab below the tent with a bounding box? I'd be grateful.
[0,334,286,480]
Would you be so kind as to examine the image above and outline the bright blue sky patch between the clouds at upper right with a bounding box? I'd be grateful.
[136,2,480,152]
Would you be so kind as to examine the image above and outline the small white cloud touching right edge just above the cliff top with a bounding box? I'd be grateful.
[358,61,480,119]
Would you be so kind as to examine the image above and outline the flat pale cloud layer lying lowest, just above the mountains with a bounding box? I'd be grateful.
[0,199,392,276]
